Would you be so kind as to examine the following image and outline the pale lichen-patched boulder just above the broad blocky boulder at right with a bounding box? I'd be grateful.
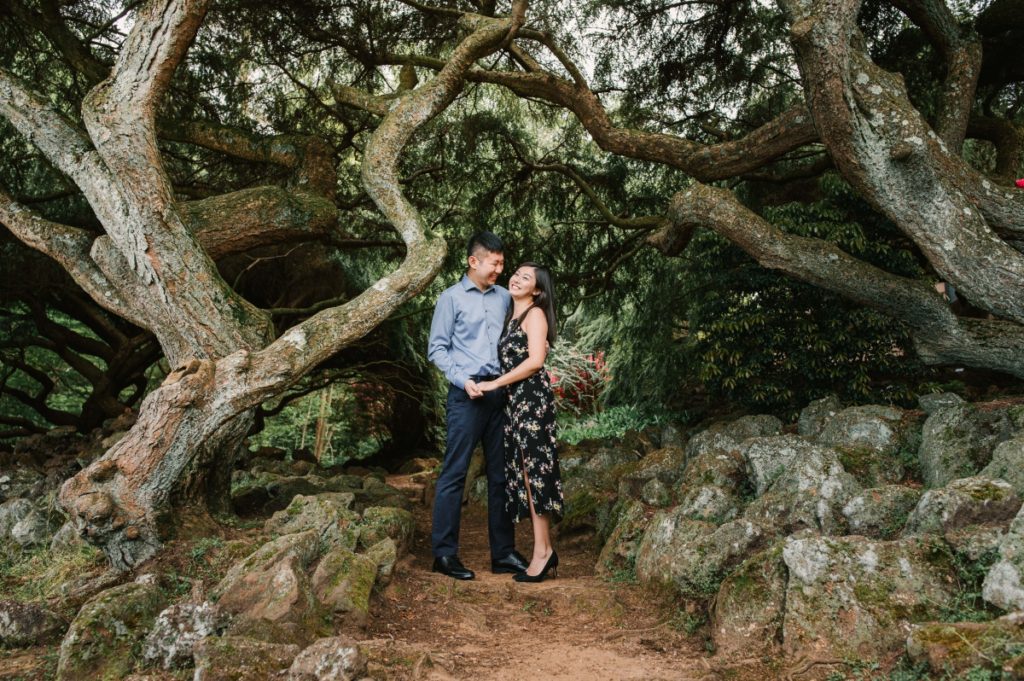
[743,445,860,535]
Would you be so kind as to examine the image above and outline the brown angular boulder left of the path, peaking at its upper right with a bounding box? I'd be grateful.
[211,529,322,643]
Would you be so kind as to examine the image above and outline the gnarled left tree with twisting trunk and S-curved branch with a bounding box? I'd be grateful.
[0,0,524,568]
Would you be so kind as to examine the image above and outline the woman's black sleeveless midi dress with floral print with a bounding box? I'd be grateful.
[498,317,563,522]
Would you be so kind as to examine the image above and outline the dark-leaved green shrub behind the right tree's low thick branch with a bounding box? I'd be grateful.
[685,173,937,411]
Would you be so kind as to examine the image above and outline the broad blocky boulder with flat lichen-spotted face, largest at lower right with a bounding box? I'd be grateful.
[782,535,956,661]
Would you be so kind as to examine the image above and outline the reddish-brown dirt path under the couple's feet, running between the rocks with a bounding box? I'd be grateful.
[362,478,709,681]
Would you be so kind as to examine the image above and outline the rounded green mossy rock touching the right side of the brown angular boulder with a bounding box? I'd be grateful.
[312,547,377,627]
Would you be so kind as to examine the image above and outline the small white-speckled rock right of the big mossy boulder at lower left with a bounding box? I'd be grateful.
[142,602,227,670]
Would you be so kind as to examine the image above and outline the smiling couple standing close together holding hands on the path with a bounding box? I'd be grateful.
[427,231,562,582]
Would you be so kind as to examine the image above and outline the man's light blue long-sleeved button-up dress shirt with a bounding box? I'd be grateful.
[427,274,512,389]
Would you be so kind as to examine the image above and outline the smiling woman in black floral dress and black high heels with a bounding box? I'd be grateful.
[479,262,562,582]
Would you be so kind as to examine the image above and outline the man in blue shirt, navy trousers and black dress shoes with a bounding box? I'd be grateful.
[427,231,526,580]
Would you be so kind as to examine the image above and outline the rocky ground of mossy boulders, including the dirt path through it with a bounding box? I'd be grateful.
[6,395,1024,681]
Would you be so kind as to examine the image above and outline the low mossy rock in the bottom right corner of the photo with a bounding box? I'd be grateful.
[906,612,1024,679]
